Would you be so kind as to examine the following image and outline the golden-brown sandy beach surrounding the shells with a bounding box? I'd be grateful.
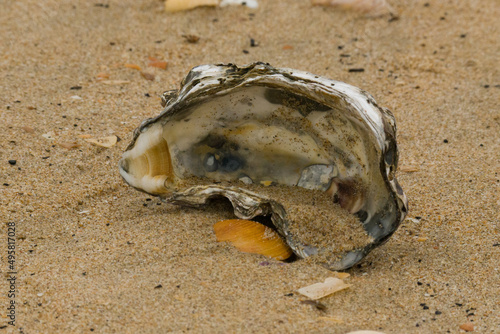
[0,0,500,333]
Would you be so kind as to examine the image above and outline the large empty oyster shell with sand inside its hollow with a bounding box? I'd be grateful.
[119,63,407,270]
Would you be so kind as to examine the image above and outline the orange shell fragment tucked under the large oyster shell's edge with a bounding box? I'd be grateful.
[214,219,292,260]
